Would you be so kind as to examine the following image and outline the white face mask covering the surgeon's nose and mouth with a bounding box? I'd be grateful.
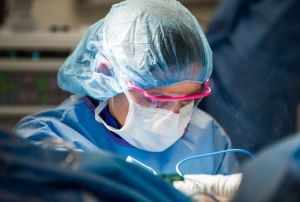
[95,101,194,152]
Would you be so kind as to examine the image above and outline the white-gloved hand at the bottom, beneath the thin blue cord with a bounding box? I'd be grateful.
[173,173,242,201]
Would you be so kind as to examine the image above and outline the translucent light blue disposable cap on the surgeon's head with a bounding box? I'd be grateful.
[58,0,212,100]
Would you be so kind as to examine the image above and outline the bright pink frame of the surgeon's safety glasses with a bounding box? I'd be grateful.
[129,80,211,102]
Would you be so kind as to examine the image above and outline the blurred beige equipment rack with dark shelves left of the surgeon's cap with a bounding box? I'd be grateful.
[0,0,84,129]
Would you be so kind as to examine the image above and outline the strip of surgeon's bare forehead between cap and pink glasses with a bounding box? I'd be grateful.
[149,82,201,95]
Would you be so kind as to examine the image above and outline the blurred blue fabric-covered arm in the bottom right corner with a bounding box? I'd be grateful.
[233,133,300,202]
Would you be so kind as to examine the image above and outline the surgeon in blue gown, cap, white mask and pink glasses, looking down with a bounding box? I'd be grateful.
[14,0,239,174]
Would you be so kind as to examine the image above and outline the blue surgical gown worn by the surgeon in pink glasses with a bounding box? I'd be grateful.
[14,96,239,174]
